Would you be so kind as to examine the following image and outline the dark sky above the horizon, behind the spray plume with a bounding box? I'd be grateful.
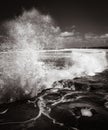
[0,0,108,47]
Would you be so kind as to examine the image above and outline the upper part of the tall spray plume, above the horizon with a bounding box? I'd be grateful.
[4,9,60,50]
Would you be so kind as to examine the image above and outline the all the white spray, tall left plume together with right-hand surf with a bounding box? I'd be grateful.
[0,9,107,102]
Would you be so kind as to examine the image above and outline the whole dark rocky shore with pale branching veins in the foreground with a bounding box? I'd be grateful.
[0,71,108,130]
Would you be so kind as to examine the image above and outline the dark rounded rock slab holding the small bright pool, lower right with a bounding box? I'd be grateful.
[50,93,108,130]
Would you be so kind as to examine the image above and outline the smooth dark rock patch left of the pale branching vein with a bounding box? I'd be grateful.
[0,100,39,124]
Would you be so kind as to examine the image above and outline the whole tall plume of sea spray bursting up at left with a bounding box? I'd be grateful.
[0,9,60,101]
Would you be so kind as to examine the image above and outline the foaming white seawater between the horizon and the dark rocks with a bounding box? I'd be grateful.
[0,49,108,102]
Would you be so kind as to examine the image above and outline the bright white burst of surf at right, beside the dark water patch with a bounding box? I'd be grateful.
[71,49,108,76]
